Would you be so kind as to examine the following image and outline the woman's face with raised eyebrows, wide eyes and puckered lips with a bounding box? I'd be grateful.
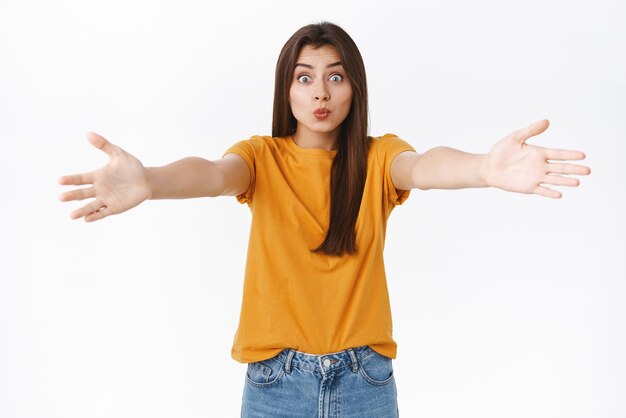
[289,45,352,138]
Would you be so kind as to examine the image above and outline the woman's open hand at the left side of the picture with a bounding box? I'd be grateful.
[58,132,152,222]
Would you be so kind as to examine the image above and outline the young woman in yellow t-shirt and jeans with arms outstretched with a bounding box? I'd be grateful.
[59,23,590,418]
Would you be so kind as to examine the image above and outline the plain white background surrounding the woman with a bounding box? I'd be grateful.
[0,0,626,418]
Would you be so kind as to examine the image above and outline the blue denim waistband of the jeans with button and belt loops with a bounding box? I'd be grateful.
[276,345,374,374]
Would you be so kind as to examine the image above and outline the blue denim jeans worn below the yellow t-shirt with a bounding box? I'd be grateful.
[241,345,399,418]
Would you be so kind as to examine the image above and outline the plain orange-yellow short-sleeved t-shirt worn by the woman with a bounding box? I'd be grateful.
[224,134,415,363]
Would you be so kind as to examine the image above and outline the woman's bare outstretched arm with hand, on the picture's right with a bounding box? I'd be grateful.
[391,119,591,198]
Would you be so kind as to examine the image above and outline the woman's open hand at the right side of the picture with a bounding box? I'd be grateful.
[483,119,591,199]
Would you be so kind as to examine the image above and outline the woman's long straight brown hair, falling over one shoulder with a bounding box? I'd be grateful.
[272,22,371,256]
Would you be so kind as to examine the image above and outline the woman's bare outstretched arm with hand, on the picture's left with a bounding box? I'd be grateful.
[58,132,250,222]
